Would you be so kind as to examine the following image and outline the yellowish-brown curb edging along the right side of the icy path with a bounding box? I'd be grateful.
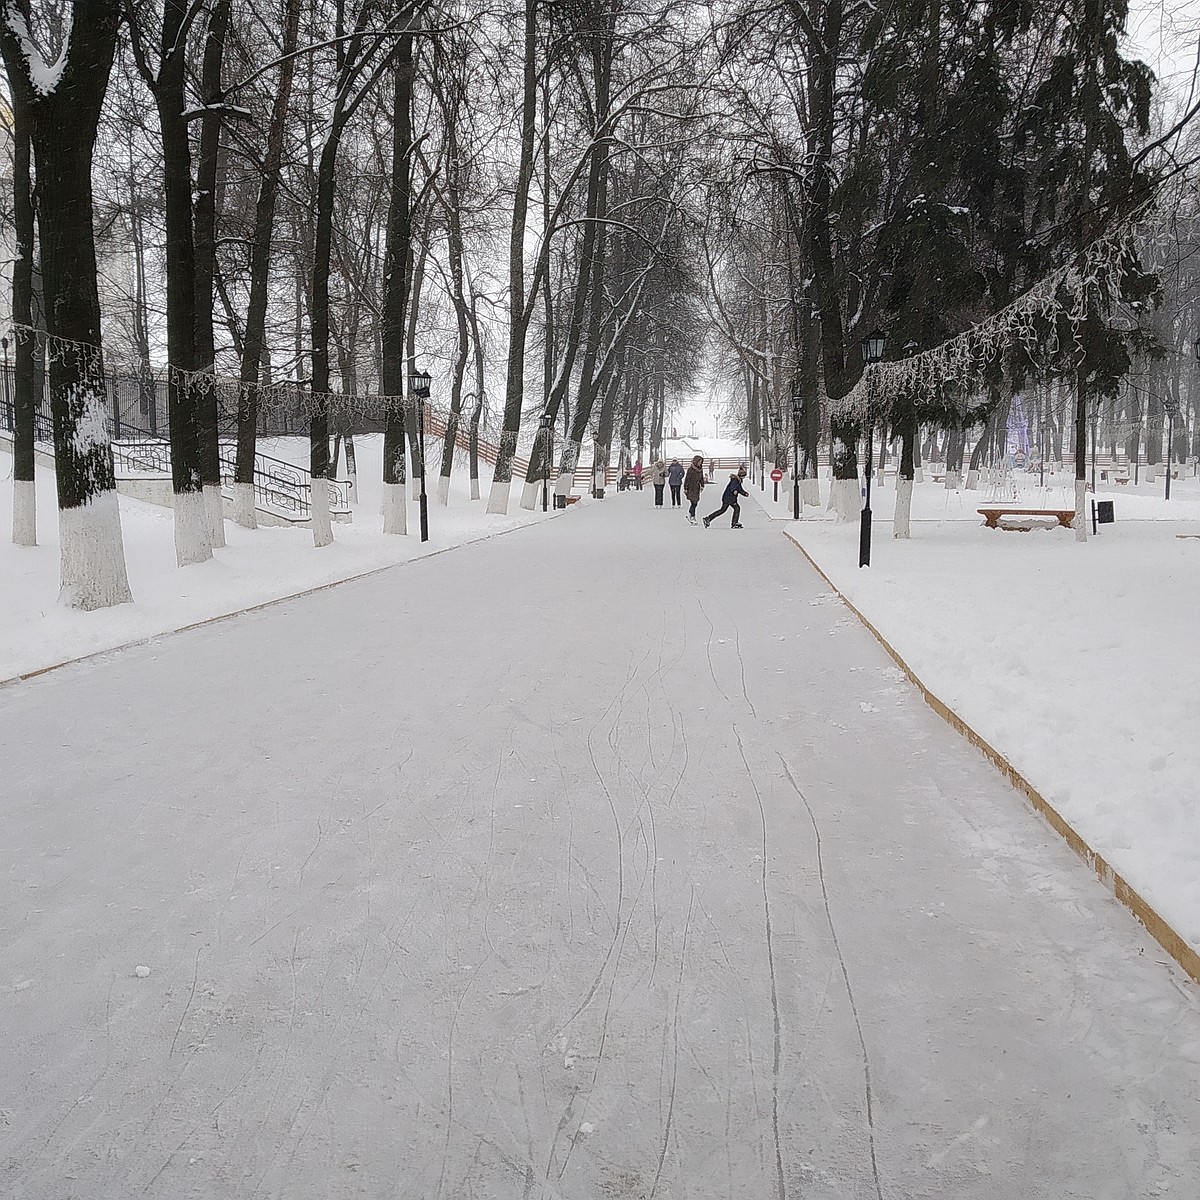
[784,529,1200,984]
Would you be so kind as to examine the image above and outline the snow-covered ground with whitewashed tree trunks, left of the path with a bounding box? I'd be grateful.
[0,437,544,680]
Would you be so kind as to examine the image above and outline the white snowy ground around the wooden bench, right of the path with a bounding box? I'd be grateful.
[752,468,1200,964]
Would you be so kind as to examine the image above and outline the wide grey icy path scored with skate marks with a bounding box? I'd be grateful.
[0,492,1200,1200]
